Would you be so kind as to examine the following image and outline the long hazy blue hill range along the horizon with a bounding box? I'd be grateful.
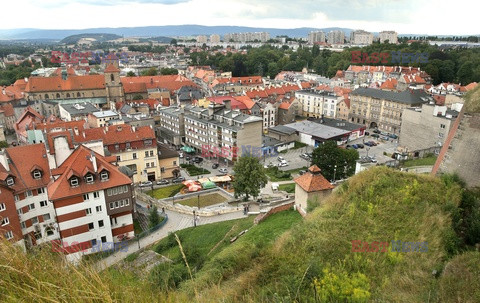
[0,25,351,40]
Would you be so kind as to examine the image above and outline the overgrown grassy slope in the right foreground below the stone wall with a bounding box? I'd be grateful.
[182,168,466,302]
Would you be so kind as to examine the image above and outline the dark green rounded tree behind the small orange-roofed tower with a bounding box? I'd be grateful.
[312,141,358,181]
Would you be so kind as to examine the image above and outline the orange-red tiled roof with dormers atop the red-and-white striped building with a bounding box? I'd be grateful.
[48,145,132,200]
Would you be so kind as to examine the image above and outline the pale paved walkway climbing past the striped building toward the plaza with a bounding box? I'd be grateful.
[96,202,245,270]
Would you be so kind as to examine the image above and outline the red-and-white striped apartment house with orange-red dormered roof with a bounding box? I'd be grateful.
[48,145,135,261]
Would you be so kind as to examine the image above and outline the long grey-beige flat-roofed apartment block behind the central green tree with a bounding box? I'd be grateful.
[185,101,262,162]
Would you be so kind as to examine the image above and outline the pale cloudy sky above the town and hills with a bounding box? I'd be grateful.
[0,0,480,35]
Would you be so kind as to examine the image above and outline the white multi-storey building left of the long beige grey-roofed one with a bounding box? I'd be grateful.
[295,90,343,118]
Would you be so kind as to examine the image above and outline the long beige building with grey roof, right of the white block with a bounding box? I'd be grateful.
[349,88,433,134]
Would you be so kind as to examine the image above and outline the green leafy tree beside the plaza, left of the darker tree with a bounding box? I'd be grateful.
[233,155,268,201]
